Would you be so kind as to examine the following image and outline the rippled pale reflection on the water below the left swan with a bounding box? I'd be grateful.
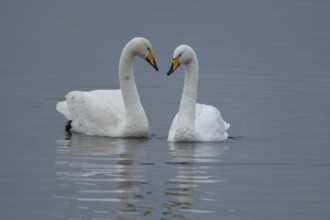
[54,134,152,219]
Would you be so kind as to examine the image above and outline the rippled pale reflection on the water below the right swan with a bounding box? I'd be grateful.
[163,143,226,219]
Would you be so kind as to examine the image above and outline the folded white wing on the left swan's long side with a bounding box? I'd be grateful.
[66,90,126,136]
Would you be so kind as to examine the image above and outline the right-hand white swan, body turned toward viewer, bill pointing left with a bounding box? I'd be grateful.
[167,45,230,142]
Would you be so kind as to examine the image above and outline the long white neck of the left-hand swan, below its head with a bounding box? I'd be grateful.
[119,44,144,118]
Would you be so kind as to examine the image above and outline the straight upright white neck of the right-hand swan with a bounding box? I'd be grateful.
[178,57,198,128]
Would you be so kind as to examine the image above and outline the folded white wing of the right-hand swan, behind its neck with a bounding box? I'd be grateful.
[195,103,230,142]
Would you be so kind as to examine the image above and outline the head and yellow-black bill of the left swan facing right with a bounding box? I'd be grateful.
[128,37,158,71]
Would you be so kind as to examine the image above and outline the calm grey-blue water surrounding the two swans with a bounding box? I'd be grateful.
[0,0,330,220]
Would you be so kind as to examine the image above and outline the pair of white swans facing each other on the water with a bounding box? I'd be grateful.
[56,37,230,142]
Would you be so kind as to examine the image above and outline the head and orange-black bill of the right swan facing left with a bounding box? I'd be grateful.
[167,44,196,76]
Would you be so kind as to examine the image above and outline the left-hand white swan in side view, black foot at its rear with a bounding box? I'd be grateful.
[56,37,158,138]
